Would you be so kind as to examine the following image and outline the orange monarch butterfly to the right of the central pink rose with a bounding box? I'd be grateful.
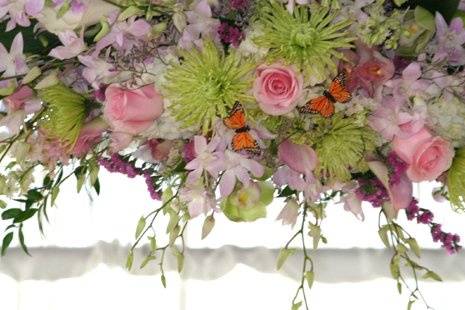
[297,71,352,117]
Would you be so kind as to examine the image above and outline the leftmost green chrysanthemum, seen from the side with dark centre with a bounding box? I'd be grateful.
[39,84,88,148]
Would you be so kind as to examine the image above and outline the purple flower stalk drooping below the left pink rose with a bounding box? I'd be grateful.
[98,154,161,200]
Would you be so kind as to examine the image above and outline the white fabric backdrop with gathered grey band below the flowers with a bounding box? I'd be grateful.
[0,171,465,310]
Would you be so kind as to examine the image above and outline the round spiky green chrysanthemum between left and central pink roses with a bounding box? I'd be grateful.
[163,40,254,133]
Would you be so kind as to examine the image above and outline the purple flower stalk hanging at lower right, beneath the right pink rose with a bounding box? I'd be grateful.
[406,199,462,254]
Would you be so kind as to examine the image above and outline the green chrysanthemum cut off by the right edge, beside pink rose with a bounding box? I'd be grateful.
[447,148,465,211]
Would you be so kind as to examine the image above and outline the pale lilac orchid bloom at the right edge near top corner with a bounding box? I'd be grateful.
[433,13,465,66]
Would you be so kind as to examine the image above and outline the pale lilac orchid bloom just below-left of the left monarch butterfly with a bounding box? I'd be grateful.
[186,136,222,183]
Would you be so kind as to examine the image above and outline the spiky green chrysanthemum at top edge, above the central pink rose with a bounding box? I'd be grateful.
[254,0,354,81]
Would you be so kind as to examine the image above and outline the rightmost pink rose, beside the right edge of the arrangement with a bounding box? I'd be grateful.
[393,129,454,182]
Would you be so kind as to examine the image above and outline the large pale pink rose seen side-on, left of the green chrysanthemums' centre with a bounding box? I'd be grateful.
[103,84,163,135]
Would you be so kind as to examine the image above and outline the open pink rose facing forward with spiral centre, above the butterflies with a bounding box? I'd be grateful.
[253,64,303,115]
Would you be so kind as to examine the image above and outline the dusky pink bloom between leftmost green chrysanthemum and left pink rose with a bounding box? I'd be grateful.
[72,118,108,157]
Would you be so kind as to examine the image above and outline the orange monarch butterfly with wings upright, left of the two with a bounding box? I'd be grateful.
[223,102,260,155]
